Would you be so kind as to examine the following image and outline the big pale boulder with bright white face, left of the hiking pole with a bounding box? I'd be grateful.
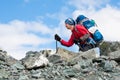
[22,53,49,69]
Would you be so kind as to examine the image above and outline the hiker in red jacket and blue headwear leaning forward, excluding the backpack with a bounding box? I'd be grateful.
[55,18,96,51]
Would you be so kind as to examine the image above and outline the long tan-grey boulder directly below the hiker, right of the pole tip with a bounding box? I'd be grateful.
[56,48,98,61]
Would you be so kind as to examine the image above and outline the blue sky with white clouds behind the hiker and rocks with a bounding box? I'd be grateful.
[0,0,120,59]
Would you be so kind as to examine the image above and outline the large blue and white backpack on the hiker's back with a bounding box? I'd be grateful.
[76,15,103,43]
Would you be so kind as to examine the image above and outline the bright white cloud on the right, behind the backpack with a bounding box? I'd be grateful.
[93,6,120,41]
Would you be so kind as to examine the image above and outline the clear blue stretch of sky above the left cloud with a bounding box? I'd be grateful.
[0,0,63,22]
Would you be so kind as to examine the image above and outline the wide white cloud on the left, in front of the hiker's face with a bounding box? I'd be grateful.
[0,20,54,59]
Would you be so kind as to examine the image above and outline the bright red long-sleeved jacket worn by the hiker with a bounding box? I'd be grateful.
[60,25,89,47]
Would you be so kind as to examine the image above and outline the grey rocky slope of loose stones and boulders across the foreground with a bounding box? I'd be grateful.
[0,44,120,80]
